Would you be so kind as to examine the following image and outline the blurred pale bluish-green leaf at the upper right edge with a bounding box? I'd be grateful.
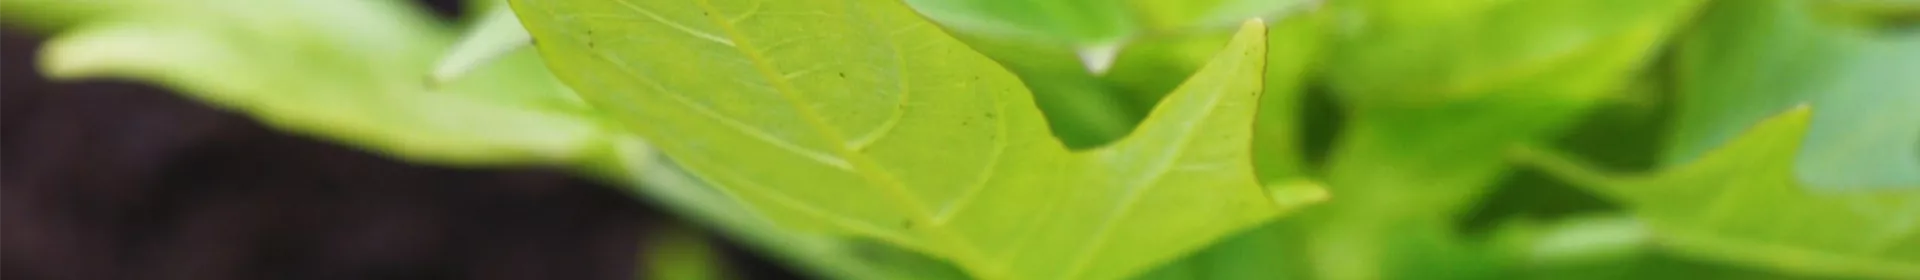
[1665,0,1920,190]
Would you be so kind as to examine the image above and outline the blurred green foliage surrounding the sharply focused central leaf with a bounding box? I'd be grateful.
[11,0,1920,280]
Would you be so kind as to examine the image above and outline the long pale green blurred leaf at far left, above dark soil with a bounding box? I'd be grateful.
[40,0,612,165]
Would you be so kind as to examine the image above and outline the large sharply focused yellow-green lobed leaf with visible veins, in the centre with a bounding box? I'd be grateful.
[515,0,1320,278]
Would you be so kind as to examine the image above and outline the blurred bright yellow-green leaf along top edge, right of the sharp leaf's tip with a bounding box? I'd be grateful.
[1329,0,1703,104]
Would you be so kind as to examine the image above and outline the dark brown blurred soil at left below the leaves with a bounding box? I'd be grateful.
[0,0,791,280]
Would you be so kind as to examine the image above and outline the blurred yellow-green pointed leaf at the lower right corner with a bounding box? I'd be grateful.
[1523,105,1920,278]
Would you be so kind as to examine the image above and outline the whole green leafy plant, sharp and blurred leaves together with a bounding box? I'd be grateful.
[0,0,1920,280]
